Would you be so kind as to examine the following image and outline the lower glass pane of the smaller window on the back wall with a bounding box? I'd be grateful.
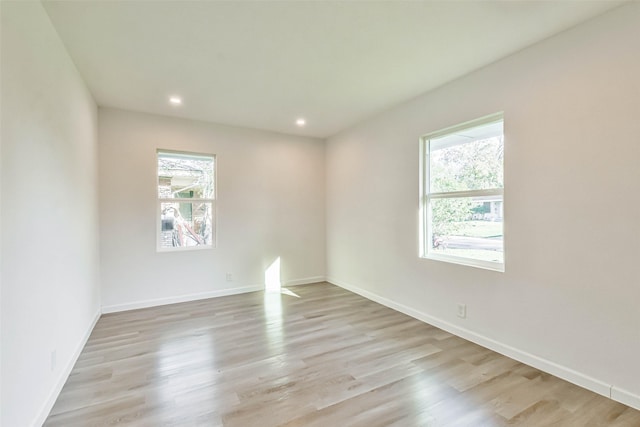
[160,202,213,249]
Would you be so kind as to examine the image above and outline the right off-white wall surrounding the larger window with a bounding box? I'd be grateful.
[326,2,640,407]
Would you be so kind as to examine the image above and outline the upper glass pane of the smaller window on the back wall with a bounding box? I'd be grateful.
[158,153,214,199]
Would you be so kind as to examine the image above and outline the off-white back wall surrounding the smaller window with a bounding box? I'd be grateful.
[99,108,325,311]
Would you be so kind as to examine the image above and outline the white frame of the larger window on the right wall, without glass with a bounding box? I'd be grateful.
[419,112,506,272]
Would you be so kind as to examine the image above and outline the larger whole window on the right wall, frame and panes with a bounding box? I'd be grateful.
[420,113,504,271]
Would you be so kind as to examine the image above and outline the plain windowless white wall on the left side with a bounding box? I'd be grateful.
[1,1,100,427]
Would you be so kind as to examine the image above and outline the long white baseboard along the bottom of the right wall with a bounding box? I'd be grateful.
[327,277,640,409]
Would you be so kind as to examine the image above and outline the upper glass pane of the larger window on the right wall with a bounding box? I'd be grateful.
[429,121,504,193]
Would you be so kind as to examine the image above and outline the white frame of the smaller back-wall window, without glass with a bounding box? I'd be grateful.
[155,148,218,252]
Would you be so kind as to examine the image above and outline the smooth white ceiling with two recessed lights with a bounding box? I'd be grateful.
[43,0,620,137]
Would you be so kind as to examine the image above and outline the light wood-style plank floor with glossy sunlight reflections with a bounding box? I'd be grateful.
[45,283,640,427]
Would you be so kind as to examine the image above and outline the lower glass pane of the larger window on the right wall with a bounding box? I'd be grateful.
[430,196,504,263]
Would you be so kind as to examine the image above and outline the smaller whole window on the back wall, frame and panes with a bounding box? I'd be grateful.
[157,150,215,251]
